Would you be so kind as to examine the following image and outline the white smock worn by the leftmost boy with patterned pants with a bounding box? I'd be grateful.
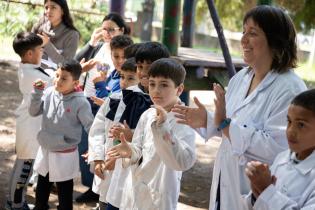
[15,63,52,159]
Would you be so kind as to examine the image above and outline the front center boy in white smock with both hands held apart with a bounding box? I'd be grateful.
[107,58,195,210]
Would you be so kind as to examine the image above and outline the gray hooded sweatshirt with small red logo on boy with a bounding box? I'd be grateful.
[29,87,94,151]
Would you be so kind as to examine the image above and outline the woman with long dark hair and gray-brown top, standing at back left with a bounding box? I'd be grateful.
[32,0,80,67]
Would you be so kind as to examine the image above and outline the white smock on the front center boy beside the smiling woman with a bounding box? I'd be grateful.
[119,108,196,210]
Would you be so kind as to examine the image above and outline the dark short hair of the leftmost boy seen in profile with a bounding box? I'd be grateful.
[13,32,43,57]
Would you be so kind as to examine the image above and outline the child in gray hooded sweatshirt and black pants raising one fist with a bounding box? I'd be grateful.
[29,60,93,210]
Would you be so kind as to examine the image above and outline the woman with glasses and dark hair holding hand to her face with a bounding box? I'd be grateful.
[75,13,130,204]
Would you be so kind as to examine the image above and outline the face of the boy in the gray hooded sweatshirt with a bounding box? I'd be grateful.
[54,68,79,95]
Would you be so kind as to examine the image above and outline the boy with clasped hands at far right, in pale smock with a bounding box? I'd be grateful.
[246,89,315,210]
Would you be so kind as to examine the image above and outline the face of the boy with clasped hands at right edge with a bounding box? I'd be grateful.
[287,104,315,160]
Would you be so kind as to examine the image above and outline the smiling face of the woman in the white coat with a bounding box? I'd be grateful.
[241,18,272,68]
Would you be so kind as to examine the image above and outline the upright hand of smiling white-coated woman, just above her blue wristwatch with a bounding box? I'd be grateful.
[213,83,226,127]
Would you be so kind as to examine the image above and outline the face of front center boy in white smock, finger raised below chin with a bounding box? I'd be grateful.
[149,77,184,111]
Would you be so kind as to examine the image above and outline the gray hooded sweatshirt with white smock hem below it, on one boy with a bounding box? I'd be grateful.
[29,87,94,182]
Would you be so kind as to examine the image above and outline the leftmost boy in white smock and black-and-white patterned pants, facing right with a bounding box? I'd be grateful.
[6,32,51,209]
